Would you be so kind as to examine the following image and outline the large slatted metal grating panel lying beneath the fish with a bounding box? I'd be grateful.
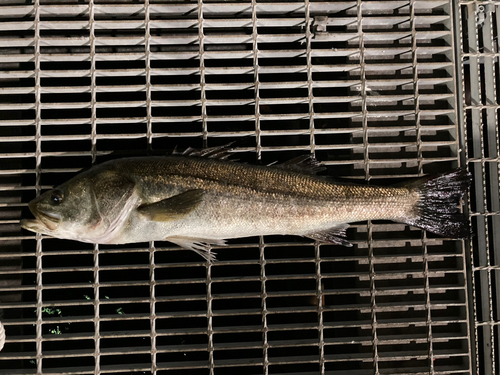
[0,0,474,375]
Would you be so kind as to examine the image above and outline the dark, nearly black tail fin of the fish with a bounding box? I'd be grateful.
[406,169,471,239]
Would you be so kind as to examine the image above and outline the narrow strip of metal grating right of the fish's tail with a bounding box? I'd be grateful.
[459,1,500,374]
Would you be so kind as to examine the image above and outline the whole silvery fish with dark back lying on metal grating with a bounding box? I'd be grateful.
[21,145,471,261]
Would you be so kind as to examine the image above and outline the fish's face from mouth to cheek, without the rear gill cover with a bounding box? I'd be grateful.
[21,178,102,240]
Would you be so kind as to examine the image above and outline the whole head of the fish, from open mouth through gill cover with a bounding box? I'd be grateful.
[21,163,139,243]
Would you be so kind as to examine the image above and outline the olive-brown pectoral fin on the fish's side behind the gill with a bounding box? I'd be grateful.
[137,189,204,221]
